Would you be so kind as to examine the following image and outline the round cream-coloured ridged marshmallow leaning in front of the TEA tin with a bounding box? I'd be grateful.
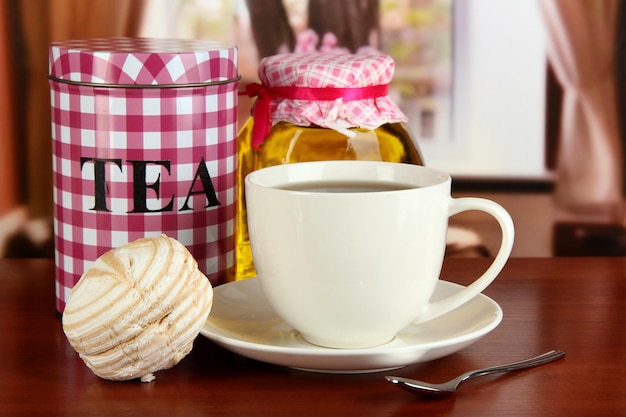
[63,235,213,382]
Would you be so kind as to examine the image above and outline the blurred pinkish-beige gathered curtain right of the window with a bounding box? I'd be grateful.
[539,0,622,223]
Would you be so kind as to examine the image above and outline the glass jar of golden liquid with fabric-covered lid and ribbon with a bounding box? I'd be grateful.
[235,52,424,280]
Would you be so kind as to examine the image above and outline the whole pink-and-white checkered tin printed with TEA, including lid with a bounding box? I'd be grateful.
[49,38,239,312]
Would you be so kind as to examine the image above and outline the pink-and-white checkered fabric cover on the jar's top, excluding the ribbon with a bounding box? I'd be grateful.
[259,52,407,131]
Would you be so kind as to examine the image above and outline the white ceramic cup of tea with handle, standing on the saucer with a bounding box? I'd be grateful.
[245,161,514,348]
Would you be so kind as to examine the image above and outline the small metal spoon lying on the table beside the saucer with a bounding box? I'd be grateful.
[385,350,565,395]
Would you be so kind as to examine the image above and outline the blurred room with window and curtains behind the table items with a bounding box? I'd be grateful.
[0,0,626,257]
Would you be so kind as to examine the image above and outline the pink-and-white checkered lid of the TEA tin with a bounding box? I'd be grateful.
[49,38,239,87]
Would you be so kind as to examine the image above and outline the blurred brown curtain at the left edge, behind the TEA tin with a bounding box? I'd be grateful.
[0,0,144,257]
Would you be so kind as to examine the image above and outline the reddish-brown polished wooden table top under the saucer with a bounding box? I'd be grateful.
[0,258,626,417]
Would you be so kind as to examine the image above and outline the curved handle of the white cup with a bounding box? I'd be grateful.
[416,197,515,323]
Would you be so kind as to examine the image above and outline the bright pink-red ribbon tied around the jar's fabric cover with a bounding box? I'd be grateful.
[239,83,389,149]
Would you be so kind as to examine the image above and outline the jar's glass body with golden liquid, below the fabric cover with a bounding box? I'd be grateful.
[235,118,424,280]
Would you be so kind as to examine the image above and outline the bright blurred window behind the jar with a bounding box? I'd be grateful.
[142,0,548,178]
